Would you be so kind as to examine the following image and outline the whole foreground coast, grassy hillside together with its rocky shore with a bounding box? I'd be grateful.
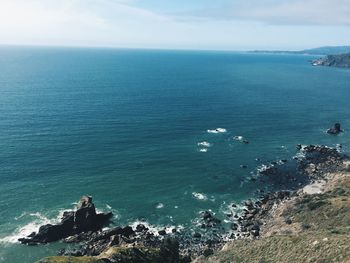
[34,148,350,263]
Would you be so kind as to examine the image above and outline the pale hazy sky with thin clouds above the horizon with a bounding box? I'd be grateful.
[0,0,350,50]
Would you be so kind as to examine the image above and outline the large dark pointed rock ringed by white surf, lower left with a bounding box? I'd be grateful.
[18,196,112,244]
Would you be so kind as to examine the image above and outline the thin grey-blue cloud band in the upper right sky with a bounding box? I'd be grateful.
[187,0,350,25]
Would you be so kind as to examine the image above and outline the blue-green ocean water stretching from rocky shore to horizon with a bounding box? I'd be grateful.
[0,47,350,262]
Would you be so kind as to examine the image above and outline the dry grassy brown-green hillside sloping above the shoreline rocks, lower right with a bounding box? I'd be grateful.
[195,167,350,263]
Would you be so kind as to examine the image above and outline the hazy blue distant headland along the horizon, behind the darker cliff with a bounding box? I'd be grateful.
[251,46,350,55]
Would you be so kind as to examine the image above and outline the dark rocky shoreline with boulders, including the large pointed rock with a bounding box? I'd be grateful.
[19,145,347,262]
